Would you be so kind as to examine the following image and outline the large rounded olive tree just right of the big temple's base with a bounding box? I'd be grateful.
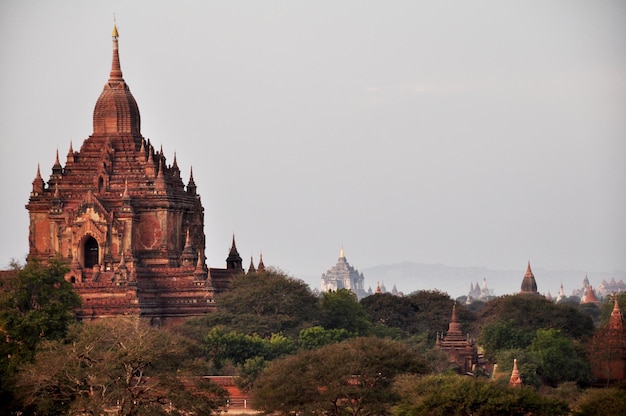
[188,270,319,337]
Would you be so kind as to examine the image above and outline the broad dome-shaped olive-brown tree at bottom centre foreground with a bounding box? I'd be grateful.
[252,337,427,415]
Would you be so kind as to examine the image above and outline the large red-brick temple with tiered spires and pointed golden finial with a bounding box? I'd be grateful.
[26,27,243,323]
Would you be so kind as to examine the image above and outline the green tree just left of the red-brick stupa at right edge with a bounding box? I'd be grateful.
[529,329,591,387]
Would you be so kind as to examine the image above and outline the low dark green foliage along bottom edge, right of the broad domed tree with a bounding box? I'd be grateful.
[392,375,568,416]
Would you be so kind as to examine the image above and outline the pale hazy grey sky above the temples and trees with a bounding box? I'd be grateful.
[0,0,626,294]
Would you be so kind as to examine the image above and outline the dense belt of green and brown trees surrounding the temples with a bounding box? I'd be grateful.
[0,260,626,415]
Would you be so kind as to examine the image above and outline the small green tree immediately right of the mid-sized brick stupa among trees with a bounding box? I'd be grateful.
[478,319,535,360]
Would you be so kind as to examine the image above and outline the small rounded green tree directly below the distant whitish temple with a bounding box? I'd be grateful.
[320,289,371,335]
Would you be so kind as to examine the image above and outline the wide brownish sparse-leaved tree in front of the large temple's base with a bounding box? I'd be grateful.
[16,318,226,415]
